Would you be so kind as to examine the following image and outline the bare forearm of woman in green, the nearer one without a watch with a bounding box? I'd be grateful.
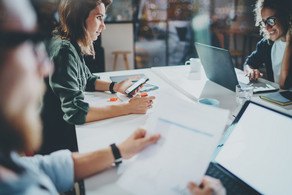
[86,103,130,122]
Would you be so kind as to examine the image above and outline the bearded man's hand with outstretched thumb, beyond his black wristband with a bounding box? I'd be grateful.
[118,128,160,159]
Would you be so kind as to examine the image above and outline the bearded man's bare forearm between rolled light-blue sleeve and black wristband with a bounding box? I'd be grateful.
[72,147,115,180]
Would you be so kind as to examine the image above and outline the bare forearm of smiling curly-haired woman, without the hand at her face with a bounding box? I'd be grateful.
[279,42,292,88]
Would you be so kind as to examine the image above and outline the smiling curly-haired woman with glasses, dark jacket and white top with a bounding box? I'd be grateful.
[244,0,292,89]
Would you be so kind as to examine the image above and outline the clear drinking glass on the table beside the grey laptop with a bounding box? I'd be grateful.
[235,85,253,106]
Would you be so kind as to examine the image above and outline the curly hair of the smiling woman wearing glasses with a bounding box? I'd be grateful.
[254,0,292,39]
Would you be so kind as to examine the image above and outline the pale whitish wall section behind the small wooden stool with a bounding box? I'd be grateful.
[101,23,134,71]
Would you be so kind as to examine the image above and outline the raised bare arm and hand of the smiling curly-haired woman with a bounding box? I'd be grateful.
[279,31,292,89]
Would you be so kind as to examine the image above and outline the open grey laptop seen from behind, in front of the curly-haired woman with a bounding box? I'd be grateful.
[195,43,279,93]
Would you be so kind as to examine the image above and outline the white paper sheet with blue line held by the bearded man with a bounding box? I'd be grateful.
[117,94,229,195]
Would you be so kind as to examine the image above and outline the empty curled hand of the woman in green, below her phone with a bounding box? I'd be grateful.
[128,94,155,114]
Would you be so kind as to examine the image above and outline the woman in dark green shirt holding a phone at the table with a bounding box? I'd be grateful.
[42,0,155,152]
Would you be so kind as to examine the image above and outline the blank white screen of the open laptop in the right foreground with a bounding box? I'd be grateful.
[215,102,292,194]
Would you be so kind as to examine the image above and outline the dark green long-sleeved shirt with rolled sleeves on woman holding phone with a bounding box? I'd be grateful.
[48,36,98,124]
